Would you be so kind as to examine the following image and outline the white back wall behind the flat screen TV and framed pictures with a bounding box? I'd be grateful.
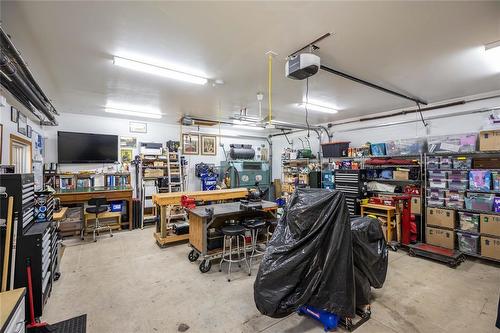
[45,113,268,191]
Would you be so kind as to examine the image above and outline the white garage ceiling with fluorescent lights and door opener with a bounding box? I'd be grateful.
[1,1,500,124]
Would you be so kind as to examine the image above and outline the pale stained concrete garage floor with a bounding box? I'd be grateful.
[43,229,500,333]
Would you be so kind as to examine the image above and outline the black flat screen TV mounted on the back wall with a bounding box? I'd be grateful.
[57,131,118,164]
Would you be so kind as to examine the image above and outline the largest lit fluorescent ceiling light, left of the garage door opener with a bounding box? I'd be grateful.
[113,56,208,84]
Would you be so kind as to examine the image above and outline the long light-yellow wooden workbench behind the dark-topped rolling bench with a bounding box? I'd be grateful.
[153,187,248,247]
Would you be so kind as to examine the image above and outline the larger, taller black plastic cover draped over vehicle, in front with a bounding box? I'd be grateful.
[254,189,355,318]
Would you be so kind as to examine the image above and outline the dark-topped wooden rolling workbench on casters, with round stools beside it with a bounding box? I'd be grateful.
[188,201,278,272]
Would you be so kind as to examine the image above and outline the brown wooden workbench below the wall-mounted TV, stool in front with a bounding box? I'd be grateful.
[54,186,133,230]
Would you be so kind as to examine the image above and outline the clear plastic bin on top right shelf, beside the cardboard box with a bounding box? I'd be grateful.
[427,133,477,153]
